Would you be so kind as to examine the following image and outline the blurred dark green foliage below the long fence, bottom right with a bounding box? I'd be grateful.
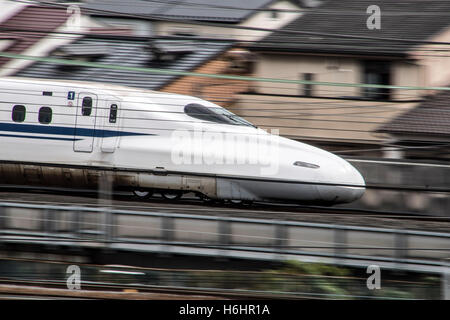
[177,260,440,299]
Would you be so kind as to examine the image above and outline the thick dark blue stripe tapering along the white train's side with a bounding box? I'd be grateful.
[0,122,155,138]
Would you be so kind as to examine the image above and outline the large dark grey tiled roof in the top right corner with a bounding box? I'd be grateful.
[252,0,450,56]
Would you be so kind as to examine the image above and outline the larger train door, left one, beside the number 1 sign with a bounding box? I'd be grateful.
[73,93,97,152]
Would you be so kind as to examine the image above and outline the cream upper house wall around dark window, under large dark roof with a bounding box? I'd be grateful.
[255,53,428,101]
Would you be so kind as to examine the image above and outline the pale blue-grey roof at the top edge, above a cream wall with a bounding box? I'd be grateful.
[82,0,274,22]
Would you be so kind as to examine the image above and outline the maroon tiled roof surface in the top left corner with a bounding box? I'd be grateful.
[0,6,68,65]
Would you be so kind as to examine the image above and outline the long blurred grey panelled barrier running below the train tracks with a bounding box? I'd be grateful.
[0,202,450,273]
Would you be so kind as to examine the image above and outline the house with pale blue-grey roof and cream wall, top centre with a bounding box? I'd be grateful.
[82,0,306,41]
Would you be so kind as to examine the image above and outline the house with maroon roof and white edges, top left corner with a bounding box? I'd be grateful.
[0,0,131,76]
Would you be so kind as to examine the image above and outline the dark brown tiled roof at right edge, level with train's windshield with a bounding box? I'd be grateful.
[376,91,450,136]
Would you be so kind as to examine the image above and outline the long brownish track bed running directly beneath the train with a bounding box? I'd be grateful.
[0,186,450,232]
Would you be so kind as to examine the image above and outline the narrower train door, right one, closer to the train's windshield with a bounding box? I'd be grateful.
[102,101,120,152]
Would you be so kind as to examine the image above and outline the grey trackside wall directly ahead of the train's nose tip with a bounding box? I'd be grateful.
[352,159,450,217]
